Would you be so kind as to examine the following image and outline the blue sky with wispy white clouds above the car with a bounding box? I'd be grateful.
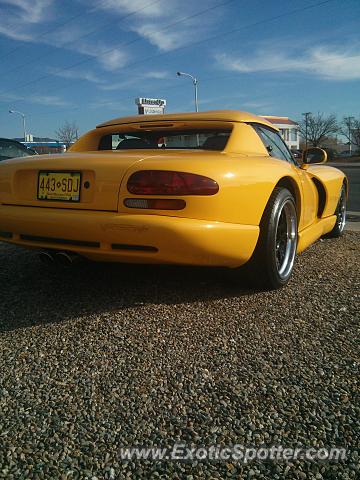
[0,0,360,137]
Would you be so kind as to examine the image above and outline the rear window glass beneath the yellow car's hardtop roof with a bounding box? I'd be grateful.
[99,129,231,151]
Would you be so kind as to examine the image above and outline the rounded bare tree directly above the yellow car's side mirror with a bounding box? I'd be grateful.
[299,113,339,147]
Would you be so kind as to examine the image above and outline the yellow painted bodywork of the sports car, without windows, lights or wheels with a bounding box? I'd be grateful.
[0,111,346,267]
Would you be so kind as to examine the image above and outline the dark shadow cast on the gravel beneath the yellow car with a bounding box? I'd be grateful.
[0,244,253,331]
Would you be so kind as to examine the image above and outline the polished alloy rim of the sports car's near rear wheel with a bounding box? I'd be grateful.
[275,200,297,279]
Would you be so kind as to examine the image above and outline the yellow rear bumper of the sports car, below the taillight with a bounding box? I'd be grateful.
[0,205,259,267]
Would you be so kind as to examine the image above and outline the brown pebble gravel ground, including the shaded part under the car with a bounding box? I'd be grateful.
[0,232,360,480]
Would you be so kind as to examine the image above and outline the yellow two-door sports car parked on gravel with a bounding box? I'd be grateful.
[0,110,348,288]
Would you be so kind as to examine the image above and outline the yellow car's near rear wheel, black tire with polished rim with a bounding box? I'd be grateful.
[245,187,298,290]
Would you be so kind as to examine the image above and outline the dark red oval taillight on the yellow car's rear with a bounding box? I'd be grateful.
[127,170,219,196]
